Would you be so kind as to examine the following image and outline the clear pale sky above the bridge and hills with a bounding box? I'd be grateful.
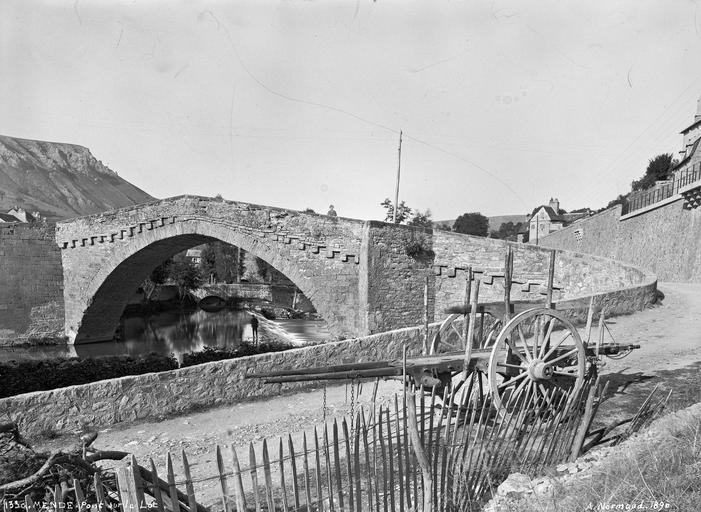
[0,0,701,220]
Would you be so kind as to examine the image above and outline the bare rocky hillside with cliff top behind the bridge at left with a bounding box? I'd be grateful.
[0,135,153,220]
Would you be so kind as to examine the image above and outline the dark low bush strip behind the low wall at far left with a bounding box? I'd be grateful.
[0,353,178,398]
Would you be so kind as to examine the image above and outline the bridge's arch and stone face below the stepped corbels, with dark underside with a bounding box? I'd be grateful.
[64,213,358,343]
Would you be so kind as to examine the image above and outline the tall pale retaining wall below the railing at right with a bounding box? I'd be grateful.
[540,199,701,282]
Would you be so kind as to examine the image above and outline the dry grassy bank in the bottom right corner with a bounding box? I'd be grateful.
[514,416,701,512]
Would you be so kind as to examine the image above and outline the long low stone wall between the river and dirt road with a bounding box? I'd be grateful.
[0,325,437,436]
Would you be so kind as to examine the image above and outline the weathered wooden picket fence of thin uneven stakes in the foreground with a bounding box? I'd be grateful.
[116,372,597,512]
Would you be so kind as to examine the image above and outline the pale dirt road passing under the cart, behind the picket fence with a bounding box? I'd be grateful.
[74,283,701,505]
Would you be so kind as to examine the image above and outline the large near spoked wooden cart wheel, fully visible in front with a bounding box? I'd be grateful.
[489,308,587,414]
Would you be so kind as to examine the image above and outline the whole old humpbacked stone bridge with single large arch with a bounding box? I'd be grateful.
[50,196,650,343]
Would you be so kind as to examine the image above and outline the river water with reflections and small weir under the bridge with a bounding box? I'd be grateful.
[0,309,332,361]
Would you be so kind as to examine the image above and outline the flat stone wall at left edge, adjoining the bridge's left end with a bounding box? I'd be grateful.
[0,224,64,345]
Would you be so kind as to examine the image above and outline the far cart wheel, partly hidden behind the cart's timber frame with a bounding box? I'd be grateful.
[429,311,501,405]
